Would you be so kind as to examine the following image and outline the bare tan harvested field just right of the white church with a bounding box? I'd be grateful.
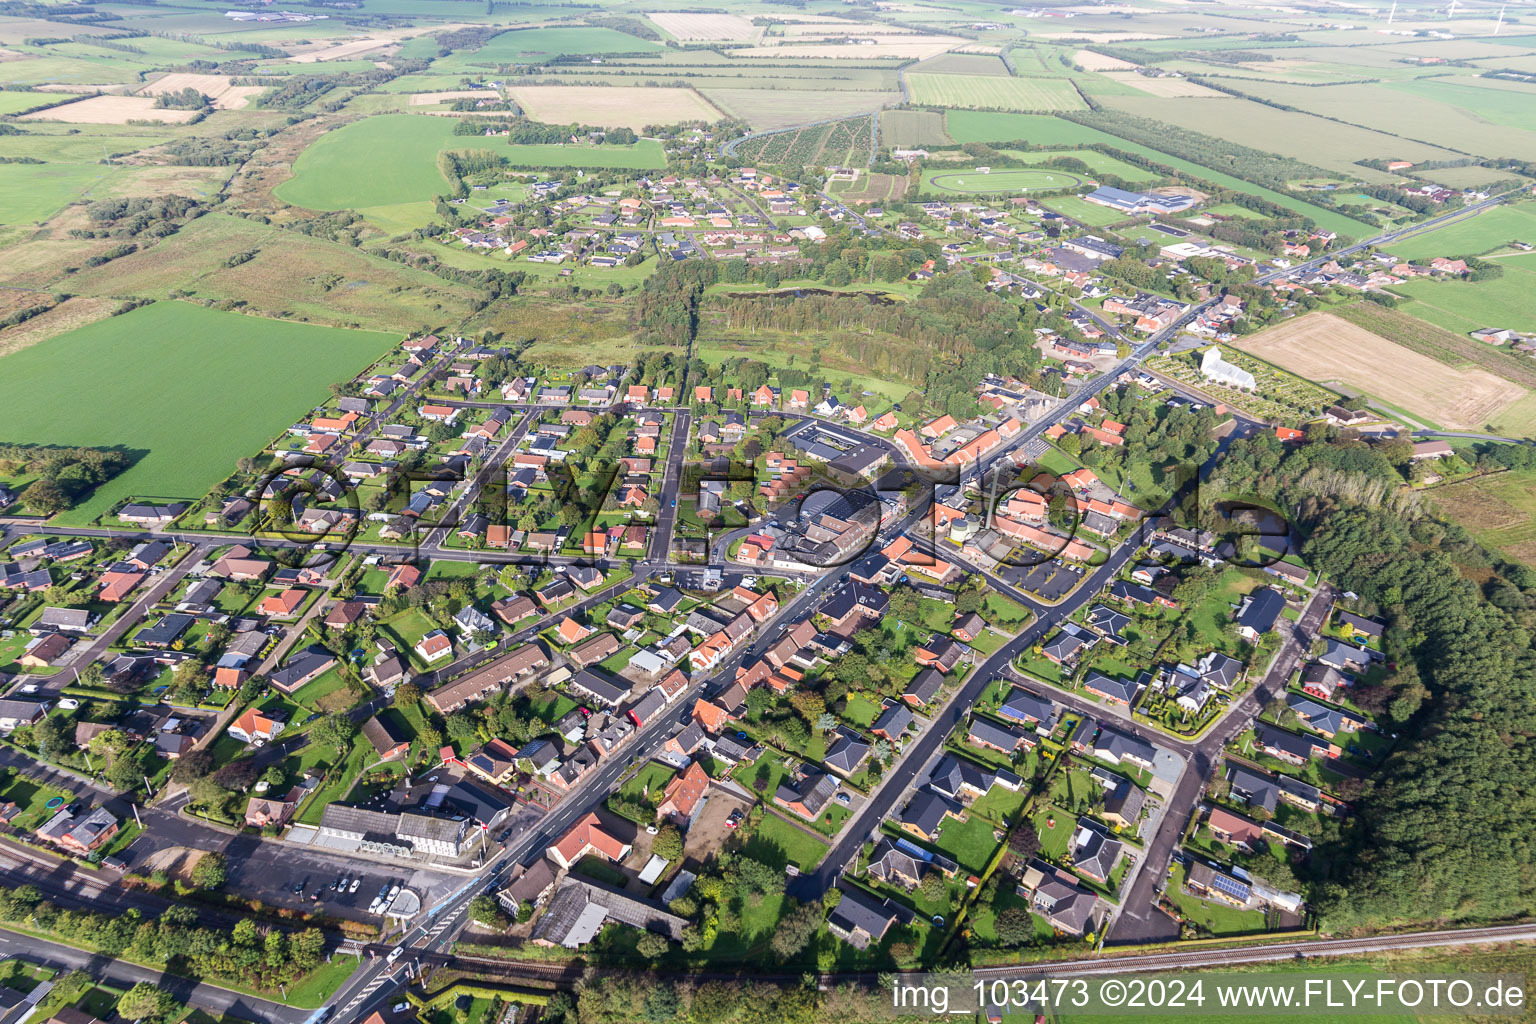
[1241,313,1527,430]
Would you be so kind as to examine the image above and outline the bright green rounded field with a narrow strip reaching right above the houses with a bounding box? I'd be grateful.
[275,114,665,215]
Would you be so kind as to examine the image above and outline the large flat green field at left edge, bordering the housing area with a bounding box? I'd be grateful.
[0,302,399,522]
